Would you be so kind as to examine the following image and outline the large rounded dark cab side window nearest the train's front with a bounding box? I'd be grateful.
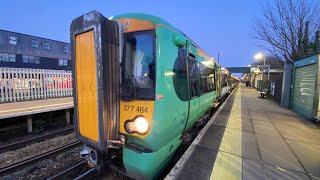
[172,48,188,101]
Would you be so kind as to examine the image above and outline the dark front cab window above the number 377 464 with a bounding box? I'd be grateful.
[121,31,155,99]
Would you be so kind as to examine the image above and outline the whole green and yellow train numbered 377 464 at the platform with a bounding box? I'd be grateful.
[70,11,239,179]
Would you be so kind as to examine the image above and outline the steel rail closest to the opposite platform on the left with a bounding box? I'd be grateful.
[0,126,74,153]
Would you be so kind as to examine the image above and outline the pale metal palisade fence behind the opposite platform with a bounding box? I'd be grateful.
[0,67,72,103]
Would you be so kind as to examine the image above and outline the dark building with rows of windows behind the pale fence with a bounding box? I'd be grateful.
[0,30,71,70]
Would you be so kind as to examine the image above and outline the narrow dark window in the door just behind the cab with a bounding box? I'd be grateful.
[189,55,199,98]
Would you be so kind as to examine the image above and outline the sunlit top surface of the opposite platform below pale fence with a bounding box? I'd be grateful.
[0,97,73,119]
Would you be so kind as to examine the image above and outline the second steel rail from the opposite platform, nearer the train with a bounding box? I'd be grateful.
[0,141,82,176]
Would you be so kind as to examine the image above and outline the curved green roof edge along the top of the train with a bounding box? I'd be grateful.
[110,13,221,66]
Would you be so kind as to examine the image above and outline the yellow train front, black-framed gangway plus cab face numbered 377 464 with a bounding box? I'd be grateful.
[70,11,159,177]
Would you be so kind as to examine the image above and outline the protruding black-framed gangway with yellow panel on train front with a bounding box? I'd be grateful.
[70,11,125,169]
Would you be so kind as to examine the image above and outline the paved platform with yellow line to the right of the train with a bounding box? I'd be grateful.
[166,85,320,180]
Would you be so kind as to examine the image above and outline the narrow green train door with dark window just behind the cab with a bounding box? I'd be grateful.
[187,53,200,128]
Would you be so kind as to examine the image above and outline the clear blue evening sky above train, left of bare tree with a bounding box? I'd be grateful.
[0,0,261,75]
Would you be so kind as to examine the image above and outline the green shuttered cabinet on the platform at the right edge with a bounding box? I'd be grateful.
[292,54,320,119]
